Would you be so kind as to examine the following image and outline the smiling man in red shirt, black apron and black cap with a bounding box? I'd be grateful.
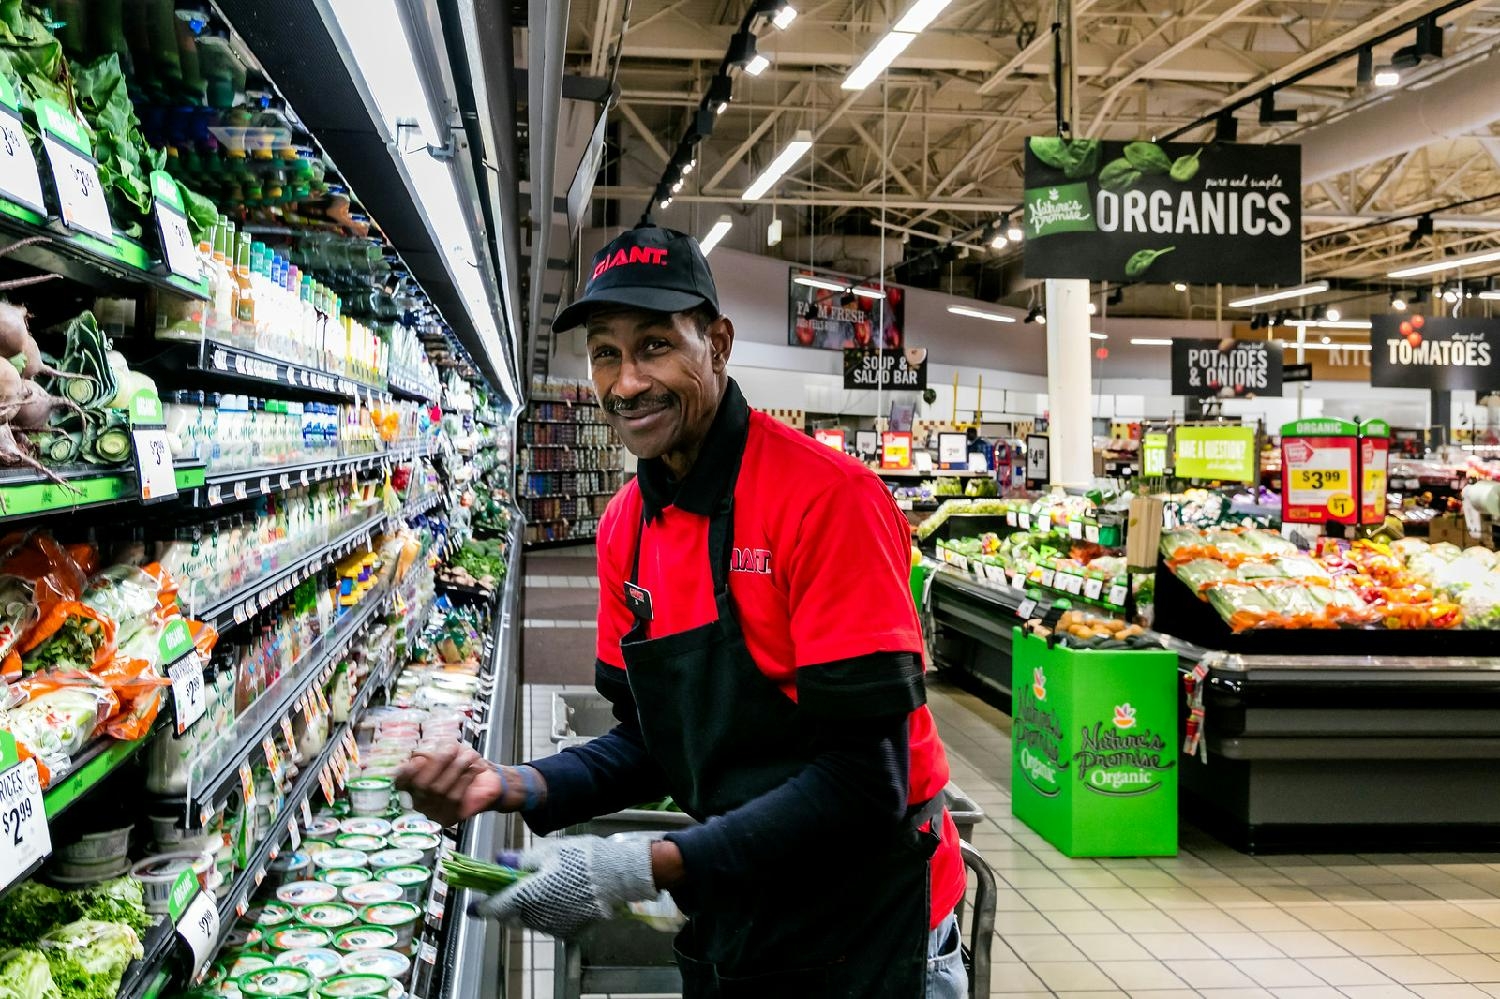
[399,227,968,999]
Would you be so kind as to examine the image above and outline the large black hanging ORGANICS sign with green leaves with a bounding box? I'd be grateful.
[1025,137,1302,285]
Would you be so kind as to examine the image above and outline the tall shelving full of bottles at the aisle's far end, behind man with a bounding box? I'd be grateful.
[516,390,624,548]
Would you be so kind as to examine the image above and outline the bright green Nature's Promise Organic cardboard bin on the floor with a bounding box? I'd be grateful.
[1011,629,1181,857]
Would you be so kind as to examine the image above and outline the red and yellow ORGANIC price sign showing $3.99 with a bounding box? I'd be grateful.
[1281,419,1359,524]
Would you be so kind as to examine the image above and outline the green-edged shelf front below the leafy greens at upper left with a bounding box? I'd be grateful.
[0,200,209,300]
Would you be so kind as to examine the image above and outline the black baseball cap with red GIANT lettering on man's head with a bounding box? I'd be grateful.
[552,225,719,333]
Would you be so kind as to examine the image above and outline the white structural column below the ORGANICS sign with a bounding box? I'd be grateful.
[1047,279,1094,486]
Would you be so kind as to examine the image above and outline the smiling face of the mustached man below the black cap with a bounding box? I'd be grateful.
[587,309,734,459]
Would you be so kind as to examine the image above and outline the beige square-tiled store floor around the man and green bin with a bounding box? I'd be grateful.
[515,549,1500,999]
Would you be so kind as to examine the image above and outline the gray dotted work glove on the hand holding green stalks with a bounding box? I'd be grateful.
[474,836,657,939]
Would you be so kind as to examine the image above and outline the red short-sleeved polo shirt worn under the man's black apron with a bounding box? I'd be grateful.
[599,399,965,927]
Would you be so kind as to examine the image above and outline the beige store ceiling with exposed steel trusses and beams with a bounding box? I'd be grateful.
[567,0,1500,314]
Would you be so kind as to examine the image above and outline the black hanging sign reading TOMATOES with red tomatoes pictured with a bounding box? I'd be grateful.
[1370,315,1500,390]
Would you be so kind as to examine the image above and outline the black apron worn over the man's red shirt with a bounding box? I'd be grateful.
[620,476,942,999]
